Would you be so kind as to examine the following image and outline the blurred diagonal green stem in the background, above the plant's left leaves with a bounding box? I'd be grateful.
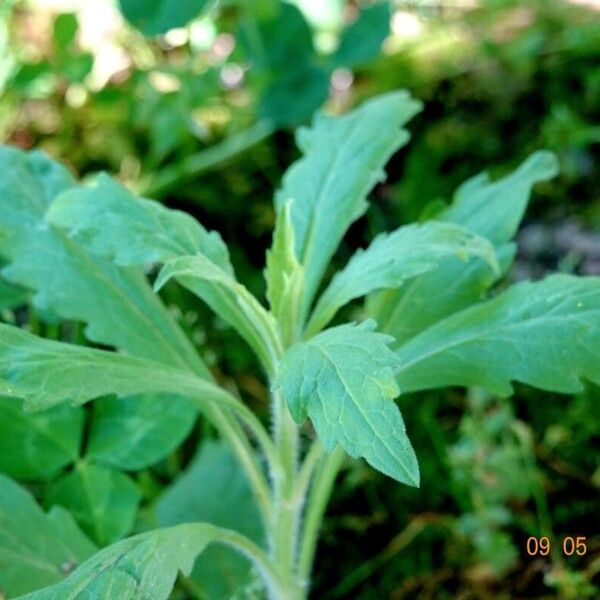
[141,121,275,198]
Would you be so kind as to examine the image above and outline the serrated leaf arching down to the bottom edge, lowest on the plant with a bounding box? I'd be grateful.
[14,523,230,600]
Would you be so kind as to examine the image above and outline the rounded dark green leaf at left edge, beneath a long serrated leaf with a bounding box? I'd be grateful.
[0,398,84,480]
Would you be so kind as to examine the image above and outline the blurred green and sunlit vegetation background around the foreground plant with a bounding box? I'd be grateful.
[0,0,600,600]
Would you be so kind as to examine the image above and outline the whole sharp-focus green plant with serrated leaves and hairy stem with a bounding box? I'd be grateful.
[0,92,600,600]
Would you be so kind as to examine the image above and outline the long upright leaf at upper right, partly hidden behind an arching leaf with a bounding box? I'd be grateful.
[367,151,557,344]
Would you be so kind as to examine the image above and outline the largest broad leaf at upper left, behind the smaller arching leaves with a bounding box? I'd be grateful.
[0,146,209,377]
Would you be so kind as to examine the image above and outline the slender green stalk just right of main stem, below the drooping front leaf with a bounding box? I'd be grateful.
[298,446,346,589]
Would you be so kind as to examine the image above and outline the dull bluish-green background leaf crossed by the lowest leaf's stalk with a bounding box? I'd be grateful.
[156,441,264,600]
